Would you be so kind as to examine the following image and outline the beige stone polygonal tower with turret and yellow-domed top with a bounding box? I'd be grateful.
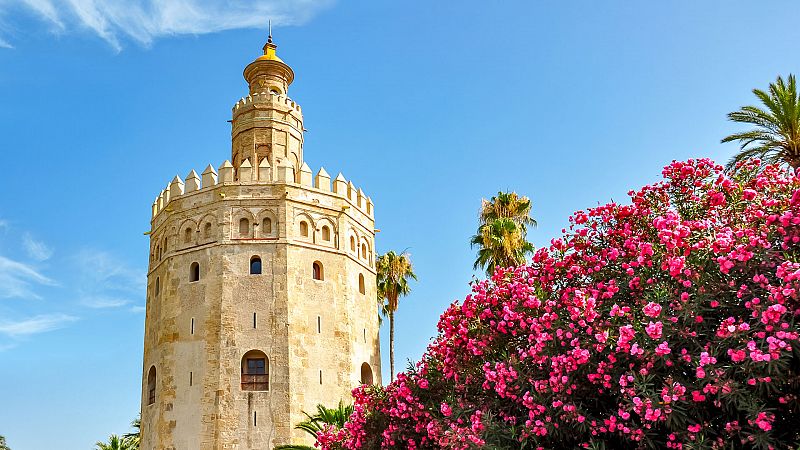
[141,36,381,450]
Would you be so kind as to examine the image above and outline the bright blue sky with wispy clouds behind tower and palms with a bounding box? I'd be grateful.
[0,0,800,450]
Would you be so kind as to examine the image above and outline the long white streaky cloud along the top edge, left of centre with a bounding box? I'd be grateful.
[0,0,334,51]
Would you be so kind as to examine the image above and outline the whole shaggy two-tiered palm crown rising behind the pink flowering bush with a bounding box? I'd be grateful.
[470,192,536,275]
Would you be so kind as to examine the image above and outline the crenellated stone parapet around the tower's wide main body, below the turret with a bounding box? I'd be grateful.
[152,159,375,219]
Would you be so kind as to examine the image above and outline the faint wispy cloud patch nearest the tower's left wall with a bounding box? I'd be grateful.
[74,249,147,308]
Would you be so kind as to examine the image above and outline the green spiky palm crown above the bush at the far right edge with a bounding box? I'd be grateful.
[722,74,800,170]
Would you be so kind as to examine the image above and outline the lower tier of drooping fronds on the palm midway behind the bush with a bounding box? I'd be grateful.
[470,218,533,276]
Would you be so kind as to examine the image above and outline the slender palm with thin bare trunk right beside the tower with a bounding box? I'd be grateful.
[375,251,417,381]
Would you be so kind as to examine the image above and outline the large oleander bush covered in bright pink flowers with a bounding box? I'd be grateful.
[319,160,800,450]
